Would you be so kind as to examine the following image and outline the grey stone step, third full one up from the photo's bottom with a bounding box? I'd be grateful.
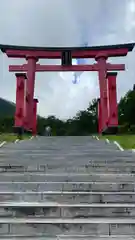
[0,189,135,204]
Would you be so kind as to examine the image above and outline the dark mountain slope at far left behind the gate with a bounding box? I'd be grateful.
[0,98,15,117]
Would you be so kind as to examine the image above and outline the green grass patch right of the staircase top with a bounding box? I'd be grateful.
[99,135,135,149]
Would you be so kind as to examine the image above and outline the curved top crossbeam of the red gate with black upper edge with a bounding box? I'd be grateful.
[0,43,135,59]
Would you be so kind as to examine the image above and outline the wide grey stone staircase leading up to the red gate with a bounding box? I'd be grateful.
[0,137,135,240]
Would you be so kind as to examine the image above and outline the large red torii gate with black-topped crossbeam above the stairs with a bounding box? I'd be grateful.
[0,43,135,133]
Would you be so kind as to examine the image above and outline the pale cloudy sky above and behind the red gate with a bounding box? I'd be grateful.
[0,0,135,118]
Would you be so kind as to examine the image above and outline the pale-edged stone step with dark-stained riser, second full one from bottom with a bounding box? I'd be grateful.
[0,201,135,219]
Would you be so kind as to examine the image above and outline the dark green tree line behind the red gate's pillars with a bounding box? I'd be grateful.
[0,87,135,136]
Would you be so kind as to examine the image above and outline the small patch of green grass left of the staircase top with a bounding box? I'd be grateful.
[0,133,30,142]
